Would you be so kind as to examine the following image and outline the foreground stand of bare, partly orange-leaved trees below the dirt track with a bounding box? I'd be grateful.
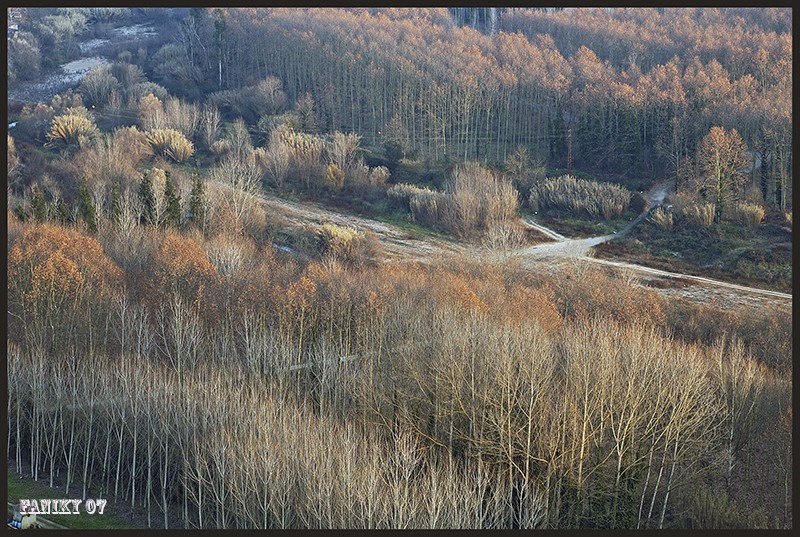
[8,207,791,528]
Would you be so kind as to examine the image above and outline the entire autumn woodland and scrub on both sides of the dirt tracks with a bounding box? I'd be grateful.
[7,8,792,529]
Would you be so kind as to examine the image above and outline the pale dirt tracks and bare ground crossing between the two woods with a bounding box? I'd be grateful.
[245,182,792,309]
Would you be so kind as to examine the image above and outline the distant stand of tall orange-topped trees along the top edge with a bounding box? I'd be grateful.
[147,9,791,209]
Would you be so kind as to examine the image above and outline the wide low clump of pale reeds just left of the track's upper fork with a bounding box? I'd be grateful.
[528,175,631,220]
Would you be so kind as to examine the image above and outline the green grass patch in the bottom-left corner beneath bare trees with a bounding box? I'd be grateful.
[7,471,136,529]
